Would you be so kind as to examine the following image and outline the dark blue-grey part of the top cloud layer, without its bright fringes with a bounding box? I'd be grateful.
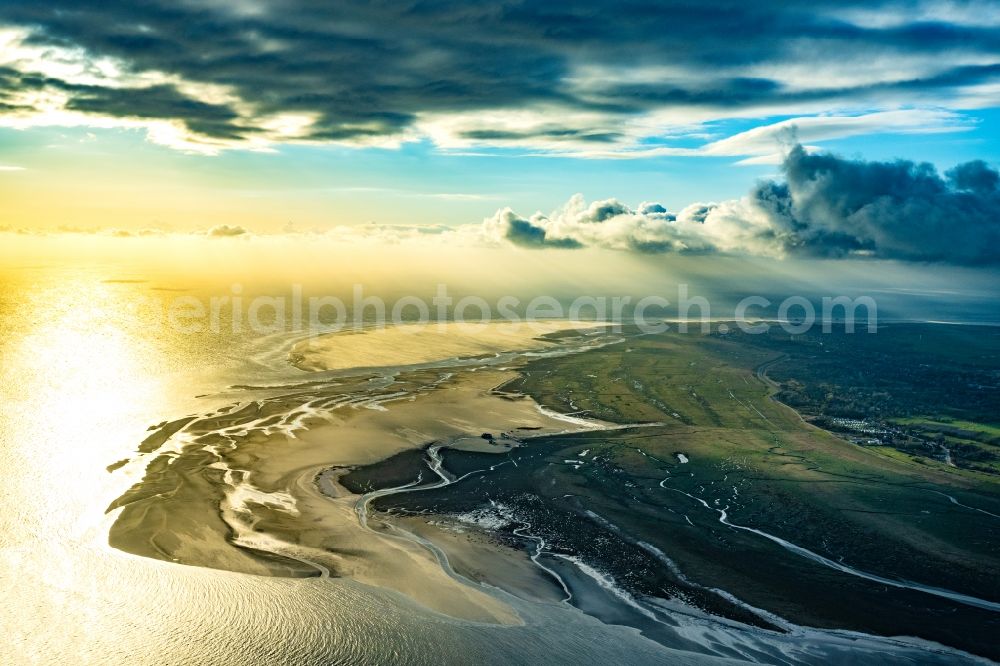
[0,0,1000,143]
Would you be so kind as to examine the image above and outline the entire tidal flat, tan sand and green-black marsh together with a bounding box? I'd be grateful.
[111,320,1000,661]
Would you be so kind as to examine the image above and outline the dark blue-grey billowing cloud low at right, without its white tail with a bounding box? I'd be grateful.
[751,146,1000,265]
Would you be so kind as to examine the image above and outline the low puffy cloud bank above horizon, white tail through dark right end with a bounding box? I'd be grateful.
[483,145,1000,265]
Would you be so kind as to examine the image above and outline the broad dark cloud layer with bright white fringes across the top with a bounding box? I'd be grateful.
[0,0,1000,150]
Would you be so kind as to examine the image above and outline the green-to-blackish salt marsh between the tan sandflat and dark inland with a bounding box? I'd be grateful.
[377,322,1000,658]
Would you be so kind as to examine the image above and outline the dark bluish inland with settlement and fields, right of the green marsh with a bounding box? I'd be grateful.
[730,324,1000,475]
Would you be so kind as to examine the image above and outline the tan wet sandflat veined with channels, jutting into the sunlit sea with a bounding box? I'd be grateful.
[109,332,612,624]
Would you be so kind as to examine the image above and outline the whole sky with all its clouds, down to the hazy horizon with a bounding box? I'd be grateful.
[0,0,1000,270]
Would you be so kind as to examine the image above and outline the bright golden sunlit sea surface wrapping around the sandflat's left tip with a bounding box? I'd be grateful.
[0,268,688,666]
